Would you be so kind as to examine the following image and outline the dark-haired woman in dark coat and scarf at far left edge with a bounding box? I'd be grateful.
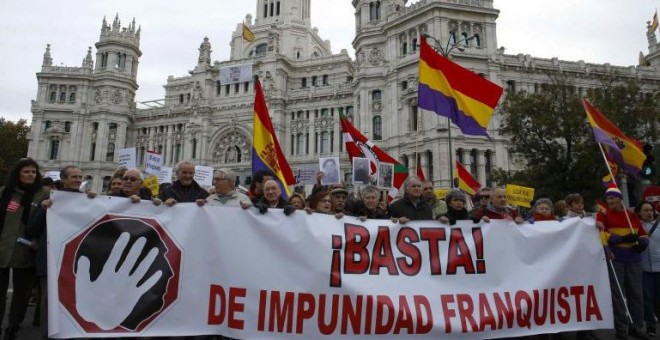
[0,158,49,339]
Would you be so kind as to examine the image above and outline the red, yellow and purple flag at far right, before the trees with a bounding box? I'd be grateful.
[582,99,646,176]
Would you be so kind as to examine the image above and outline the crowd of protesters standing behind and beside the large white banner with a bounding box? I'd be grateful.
[0,158,660,339]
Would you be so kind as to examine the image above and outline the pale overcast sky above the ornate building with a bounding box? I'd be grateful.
[0,0,657,122]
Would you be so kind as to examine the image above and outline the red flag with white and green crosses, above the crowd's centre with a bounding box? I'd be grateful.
[339,113,408,198]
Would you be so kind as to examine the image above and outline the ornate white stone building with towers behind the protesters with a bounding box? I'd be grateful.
[28,0,660,190]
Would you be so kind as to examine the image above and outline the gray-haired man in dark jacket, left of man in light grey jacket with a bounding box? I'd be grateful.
[160,161,209,207]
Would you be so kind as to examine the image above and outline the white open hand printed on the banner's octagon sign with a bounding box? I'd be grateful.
[76,232,163,330]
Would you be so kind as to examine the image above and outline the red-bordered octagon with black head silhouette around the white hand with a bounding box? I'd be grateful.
[57,214,182,333]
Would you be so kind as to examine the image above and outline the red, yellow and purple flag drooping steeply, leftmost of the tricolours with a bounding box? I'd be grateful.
[252,80,296,199]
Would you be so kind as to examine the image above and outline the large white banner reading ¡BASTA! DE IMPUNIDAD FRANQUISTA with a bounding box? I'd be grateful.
[47,192,613,339]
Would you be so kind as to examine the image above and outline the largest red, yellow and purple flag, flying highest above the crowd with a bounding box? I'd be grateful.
[417,36,504,137]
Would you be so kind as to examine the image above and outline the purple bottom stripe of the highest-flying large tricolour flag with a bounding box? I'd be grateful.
[417,84,488,137]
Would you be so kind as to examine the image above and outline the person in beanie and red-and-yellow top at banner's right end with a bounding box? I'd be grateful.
[596,184,649,339]
